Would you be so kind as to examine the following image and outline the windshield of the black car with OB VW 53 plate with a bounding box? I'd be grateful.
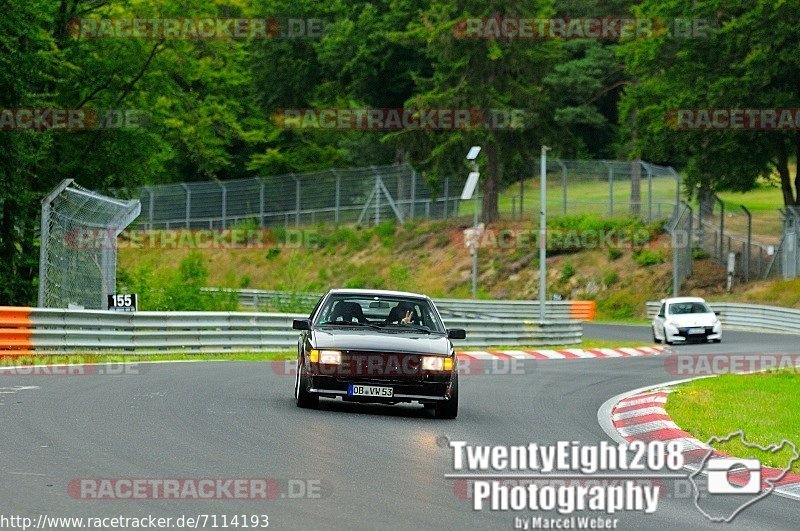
[314,294,445,333]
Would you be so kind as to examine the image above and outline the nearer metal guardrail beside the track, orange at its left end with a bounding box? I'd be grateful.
[0,307,583,355]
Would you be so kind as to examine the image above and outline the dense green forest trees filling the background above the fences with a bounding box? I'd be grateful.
[0,0,800,304]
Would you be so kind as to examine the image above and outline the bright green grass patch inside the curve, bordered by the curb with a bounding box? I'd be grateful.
[667,370,800,473]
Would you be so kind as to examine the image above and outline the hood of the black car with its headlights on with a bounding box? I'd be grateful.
[312,329,450,356]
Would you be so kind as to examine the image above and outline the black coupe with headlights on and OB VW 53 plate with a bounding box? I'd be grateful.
[293,289,466,419]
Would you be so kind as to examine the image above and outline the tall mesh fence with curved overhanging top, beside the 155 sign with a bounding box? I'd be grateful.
[39,179,140,309]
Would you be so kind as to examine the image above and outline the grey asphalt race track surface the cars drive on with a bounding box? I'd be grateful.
[0,325,800,529]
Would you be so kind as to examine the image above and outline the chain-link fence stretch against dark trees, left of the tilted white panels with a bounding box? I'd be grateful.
[141,164,466,229]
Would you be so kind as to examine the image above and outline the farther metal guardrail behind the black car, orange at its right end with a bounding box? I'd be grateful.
[205,288,595,321]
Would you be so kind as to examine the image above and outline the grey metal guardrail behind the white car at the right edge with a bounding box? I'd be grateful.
[647,301,800,334]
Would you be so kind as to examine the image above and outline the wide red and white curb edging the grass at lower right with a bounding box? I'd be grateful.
[597,376,800,500]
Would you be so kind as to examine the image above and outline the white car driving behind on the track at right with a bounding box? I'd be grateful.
[653,297,722,345]
